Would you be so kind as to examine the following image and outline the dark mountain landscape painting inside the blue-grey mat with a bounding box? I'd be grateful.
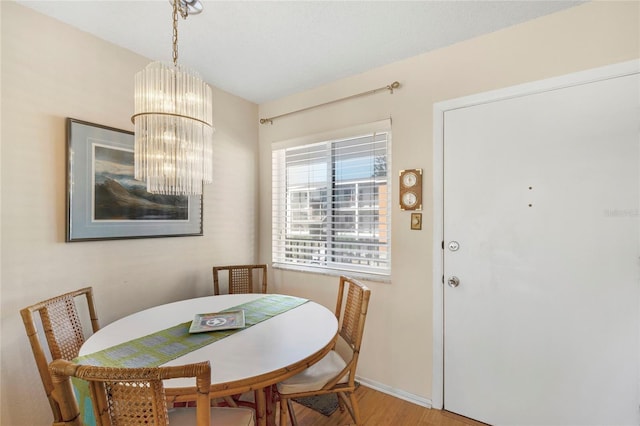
[93,144,189,221]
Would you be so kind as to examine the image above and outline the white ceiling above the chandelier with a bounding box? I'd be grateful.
[19,0,583,104]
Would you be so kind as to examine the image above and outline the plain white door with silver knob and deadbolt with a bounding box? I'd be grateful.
[443,69,640,425]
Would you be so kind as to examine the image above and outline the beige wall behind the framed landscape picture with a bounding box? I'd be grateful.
[0,1,258,426]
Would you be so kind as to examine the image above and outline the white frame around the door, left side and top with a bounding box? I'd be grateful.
[431,59,640,410]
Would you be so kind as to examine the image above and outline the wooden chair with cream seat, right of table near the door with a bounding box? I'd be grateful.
[276,276,371,426]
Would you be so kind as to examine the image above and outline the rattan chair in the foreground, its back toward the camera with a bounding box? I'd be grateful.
[49,359,255,426]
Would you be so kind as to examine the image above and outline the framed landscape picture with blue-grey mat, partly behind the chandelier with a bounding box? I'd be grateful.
[66,118,202,242]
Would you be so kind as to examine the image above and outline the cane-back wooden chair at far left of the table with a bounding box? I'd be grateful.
[20,287,100,422]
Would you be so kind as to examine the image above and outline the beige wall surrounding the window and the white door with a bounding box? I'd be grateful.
[259,2,640,404]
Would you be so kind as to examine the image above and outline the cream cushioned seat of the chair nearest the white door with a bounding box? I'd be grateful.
[278,351,349,394]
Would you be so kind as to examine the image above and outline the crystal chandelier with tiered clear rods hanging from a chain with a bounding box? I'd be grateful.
[131,0,213,195]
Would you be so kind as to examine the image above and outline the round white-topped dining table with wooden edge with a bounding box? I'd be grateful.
[80,294,338,425]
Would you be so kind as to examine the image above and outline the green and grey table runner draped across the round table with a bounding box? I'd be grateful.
[73,294,308,426]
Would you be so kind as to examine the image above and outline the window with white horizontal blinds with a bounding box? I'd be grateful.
[272,120,391,276]
